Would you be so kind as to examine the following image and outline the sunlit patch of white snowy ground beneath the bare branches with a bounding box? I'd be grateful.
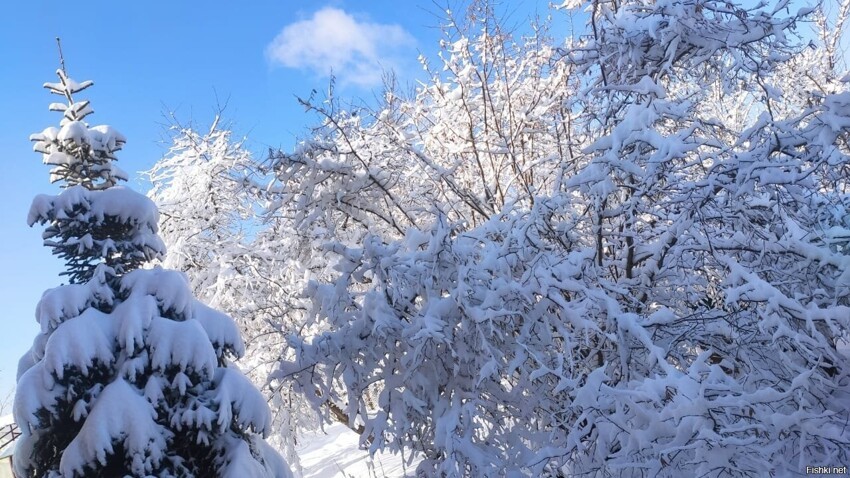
[296,424,416,478]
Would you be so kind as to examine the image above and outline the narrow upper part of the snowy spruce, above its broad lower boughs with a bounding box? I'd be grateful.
[27,70,157,282]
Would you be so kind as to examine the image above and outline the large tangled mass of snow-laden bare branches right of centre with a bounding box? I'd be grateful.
[268,1,850,476]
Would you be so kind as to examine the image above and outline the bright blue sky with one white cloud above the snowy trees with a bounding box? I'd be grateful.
[0,0,548,401]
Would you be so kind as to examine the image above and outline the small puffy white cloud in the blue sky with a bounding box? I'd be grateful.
[266,7,415,87]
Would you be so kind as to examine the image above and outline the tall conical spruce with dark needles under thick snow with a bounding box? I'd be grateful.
[14,70,291,478]
